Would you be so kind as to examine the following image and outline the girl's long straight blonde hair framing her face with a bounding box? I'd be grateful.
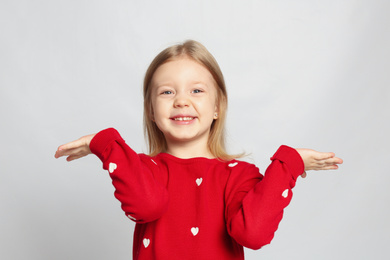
[143,40,239,160]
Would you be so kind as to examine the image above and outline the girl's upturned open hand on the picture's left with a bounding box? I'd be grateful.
[54,134,96,162]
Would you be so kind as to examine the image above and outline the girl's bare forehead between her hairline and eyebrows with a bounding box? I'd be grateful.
[152,57,216,85]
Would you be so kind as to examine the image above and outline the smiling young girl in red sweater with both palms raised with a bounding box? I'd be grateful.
[55,41,342,260]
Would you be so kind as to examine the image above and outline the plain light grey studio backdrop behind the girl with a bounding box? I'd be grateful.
[0,0,390,260]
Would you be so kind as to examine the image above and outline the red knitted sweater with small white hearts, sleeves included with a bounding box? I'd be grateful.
[90,128,304,260]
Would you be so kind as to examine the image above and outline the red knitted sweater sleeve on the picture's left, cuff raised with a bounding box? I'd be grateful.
[90,128,168,223]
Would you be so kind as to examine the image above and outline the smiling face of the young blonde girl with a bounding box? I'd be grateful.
[151,58,217,150]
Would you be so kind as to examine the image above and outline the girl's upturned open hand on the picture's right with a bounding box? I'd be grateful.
[296,148,343,178]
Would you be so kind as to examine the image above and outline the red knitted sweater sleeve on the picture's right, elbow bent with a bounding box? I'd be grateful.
[225,146,304,249]
